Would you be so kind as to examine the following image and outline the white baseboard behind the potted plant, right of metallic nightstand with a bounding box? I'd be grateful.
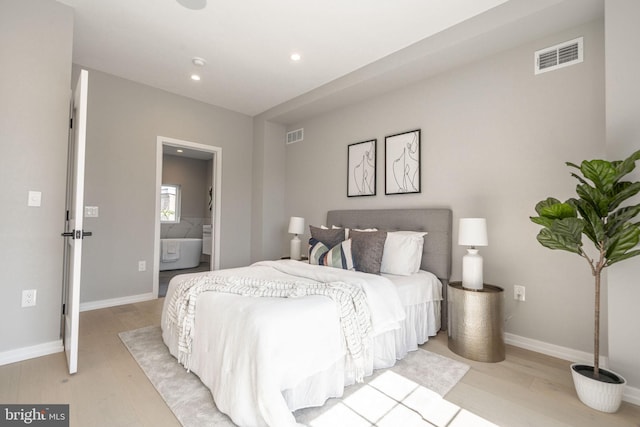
[504,333,640,405]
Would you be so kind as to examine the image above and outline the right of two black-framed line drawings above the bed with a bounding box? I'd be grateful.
[384,129,420,194]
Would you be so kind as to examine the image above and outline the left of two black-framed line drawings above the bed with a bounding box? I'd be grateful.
[347,139,378,197]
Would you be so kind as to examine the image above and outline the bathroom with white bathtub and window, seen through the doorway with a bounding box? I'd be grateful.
[158,146,214,297]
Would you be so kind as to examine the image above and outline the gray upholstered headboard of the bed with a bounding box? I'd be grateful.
[327,208,453,329]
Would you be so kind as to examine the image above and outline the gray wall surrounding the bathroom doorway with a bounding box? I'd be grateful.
[74,66,253,303]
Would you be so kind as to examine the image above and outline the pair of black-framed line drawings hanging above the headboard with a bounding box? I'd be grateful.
[347,129,420,197]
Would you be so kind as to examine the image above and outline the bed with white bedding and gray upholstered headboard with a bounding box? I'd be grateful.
[162,209,452,427]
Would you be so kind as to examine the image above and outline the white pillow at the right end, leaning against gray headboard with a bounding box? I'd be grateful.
[380,231,427,276]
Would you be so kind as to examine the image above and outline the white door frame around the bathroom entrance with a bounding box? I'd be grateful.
[153,136,222,295]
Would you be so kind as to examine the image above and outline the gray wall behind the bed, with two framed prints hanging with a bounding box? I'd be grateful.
[273,21,606,358]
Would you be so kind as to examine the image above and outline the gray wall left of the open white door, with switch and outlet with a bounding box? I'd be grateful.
[0,0,73,352]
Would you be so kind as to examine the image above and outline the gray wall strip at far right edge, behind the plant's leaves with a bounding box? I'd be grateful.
[605,0,640,392]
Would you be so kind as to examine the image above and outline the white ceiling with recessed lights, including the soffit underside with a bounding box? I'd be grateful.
[58,0,602,118]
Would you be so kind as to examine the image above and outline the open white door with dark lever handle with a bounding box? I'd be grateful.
[63,70,91,374]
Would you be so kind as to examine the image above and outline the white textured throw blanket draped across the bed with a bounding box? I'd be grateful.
[167,275,371,382]
